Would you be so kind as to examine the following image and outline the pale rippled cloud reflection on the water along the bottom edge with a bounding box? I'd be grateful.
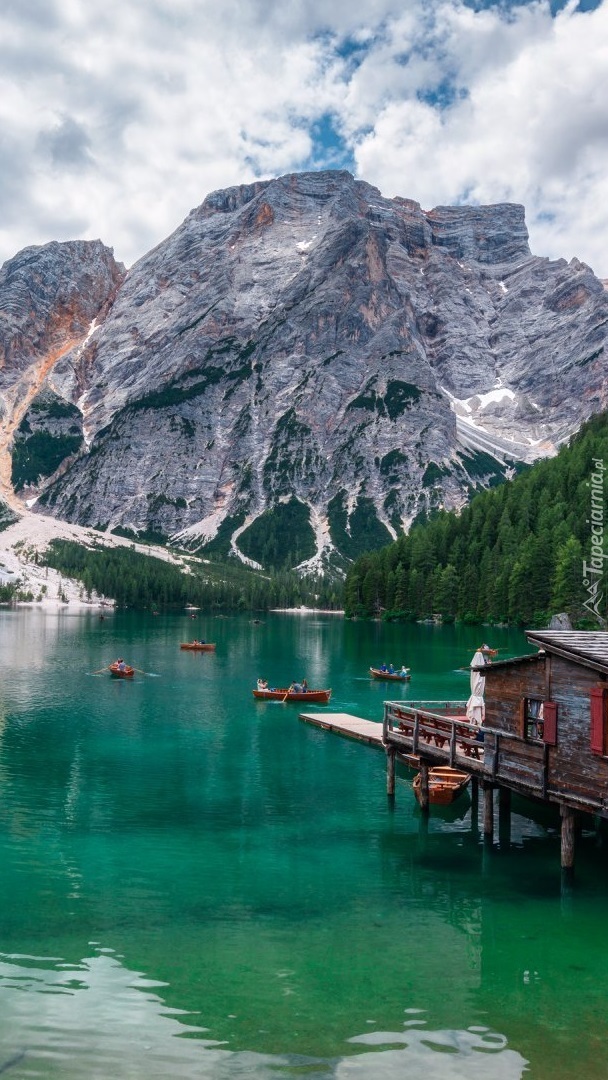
[0,942,526,1080]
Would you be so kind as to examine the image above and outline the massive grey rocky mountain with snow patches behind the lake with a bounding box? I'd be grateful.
[0,172,608,570]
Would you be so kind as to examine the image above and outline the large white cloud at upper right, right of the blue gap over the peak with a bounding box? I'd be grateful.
[351,3,608,275]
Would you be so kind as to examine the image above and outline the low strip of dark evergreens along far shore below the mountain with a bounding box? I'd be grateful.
[41,540,341,611]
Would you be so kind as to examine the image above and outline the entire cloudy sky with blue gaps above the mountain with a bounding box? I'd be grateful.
[0,0,608,278]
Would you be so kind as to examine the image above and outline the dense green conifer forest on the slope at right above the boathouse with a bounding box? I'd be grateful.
[344,414,608,629]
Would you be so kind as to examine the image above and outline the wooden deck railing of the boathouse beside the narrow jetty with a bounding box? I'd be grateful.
[382,701,484,766]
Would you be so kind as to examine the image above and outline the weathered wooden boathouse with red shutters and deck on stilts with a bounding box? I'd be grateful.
[382,630,608,869]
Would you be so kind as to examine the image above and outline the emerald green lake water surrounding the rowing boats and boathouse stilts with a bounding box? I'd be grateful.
[0,608,608,1080]
